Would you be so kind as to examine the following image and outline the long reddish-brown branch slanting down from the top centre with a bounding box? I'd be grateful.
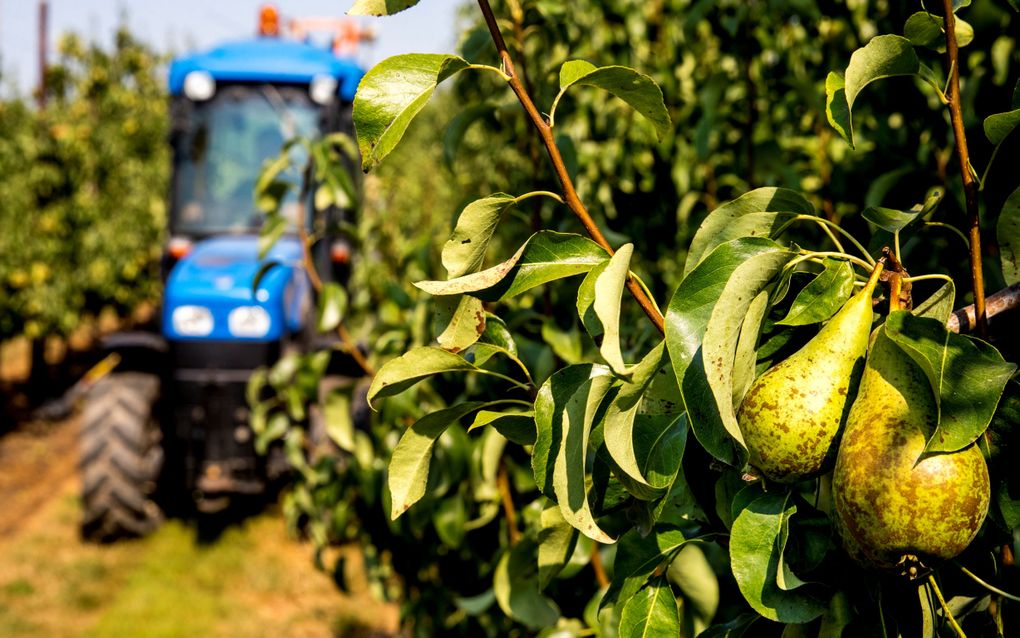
[478,0,665,334]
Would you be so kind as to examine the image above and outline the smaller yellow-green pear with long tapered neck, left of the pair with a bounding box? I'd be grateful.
[736,264,882,483]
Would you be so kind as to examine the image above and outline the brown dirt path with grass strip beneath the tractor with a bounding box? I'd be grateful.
[0,421,397,638]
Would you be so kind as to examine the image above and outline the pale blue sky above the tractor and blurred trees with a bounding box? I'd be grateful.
[0,0,466,95]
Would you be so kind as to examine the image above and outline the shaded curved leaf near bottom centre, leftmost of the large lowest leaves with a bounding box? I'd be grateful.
[493,536,560,630]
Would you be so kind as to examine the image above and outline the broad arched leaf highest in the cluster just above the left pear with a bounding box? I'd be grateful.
[683,187,815,277]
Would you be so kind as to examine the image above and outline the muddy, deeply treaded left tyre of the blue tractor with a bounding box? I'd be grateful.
[80,373,163,543]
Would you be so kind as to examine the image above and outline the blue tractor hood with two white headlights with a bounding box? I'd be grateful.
[163,236,310,341]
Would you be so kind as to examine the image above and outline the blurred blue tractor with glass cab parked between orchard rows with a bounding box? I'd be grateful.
[81,6,363,541]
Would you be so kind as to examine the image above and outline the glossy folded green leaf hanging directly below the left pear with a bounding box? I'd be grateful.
[729,493,826,623]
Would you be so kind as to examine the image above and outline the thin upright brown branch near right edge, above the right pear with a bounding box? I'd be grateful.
[942,0,988,338]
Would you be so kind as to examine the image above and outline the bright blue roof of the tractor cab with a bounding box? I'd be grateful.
[169,38,365,101]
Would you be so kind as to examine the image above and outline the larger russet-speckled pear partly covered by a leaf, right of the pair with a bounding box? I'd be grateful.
[832,328,989,569]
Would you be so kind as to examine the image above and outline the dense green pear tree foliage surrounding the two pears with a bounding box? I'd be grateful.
[250,0,1017,636]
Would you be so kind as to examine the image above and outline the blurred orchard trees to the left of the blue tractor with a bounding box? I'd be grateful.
[0,29,169,339]
